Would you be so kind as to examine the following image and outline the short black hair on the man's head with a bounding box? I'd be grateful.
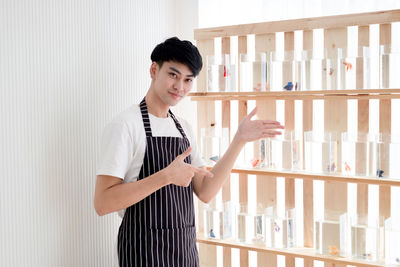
[151,37,203,76]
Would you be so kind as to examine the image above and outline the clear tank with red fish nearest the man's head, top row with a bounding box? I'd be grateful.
[207,54,237,92]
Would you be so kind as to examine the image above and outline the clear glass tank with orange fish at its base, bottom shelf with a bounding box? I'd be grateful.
[314,212,350,256]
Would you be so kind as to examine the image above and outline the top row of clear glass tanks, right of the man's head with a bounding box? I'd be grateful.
[207,46,400,92]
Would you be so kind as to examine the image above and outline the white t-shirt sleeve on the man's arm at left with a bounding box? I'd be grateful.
[96,122,133,179]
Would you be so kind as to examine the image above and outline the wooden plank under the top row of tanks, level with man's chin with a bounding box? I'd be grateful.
[189,88,400,101]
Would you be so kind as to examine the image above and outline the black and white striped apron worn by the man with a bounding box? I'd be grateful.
[118,99,199,267]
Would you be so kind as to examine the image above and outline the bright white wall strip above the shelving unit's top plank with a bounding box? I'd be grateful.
[199,0,400,28]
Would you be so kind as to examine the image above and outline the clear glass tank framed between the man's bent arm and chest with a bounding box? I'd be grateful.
[200,127,229,166]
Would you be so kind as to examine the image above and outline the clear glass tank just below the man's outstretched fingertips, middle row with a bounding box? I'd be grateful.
[264,131,301,170]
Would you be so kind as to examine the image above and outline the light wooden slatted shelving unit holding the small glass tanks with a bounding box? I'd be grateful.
[189,10,400,267]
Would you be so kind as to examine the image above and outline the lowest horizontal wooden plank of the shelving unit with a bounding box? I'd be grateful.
[197,237,388,267]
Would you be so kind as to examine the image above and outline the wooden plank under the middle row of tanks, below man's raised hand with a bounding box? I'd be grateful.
[207,166,400,186]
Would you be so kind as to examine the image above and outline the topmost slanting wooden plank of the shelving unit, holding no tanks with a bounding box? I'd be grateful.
[194,9,400,40]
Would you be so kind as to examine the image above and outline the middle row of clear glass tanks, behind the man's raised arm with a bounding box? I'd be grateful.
[201,129,400,179]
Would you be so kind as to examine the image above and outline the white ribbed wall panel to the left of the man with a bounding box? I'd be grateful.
[0,0,178,267]
